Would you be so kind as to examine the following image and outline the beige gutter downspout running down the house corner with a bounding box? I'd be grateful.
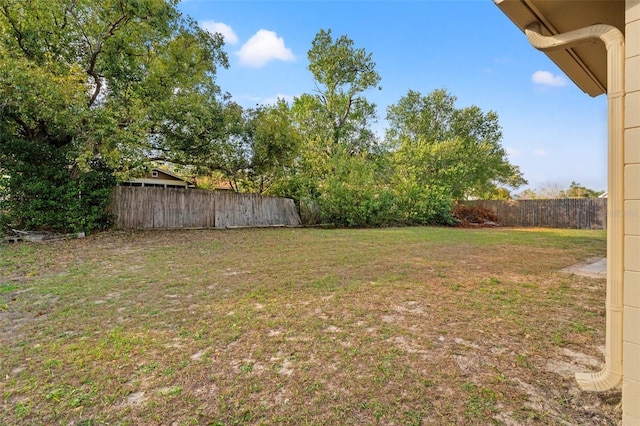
[525,23,625,391]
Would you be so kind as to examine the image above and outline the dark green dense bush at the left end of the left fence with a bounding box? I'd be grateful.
[0,140,115,232]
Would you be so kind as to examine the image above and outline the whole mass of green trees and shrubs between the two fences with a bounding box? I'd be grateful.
[238,42,525,226]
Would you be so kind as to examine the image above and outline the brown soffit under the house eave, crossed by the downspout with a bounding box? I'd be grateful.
[494,0,625,96]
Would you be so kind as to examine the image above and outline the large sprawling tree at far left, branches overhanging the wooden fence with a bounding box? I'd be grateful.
[0,0,228,229]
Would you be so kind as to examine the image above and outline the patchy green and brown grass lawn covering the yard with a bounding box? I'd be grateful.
[0,228,620,425]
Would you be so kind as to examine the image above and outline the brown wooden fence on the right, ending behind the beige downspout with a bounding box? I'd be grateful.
[460,198,607,229]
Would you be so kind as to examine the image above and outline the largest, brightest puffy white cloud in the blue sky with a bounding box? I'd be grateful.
[237,30,296,68]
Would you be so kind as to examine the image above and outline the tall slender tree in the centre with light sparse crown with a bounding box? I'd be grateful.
[278,30,390,225]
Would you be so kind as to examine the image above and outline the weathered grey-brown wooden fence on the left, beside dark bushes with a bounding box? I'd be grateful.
[111,186,300,229]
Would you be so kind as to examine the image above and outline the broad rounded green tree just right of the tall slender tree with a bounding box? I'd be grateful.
[387,90,526,199]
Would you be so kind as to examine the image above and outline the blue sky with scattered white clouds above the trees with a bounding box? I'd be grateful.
[180,0,607,192]
